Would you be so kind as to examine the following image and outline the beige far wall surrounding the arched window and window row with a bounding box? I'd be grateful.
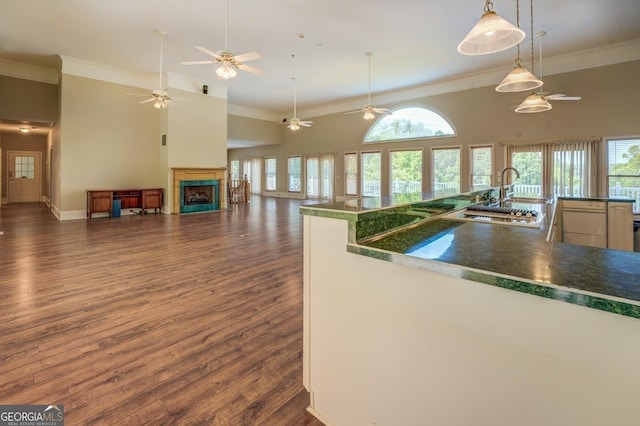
[229,61,640,195]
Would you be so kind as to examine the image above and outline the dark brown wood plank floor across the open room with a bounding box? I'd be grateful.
[0,197,322,426]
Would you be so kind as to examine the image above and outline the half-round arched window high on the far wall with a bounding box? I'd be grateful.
[364,107,456,143]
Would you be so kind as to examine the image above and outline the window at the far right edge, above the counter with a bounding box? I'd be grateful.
[607,139,640,214]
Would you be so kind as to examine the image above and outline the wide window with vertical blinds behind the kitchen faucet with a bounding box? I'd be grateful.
[505,140,598,197]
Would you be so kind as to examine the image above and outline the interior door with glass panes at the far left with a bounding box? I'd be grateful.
[7,151,42,203]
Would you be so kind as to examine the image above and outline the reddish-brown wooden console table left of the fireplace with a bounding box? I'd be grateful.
[87,188,164,219]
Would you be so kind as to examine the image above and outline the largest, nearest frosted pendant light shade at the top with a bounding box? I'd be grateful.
[458,0,525,55]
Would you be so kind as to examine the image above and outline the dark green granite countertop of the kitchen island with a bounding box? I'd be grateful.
[301,194,640,319]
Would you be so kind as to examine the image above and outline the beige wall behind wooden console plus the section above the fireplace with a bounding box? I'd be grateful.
[54,74,227,219]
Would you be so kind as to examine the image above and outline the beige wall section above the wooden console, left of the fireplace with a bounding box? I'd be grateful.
[57,74,164,218]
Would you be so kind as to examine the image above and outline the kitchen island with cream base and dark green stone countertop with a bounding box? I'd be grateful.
[301,193,640,425]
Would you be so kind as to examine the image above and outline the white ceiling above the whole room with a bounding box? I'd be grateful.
[0,0,640,120]
